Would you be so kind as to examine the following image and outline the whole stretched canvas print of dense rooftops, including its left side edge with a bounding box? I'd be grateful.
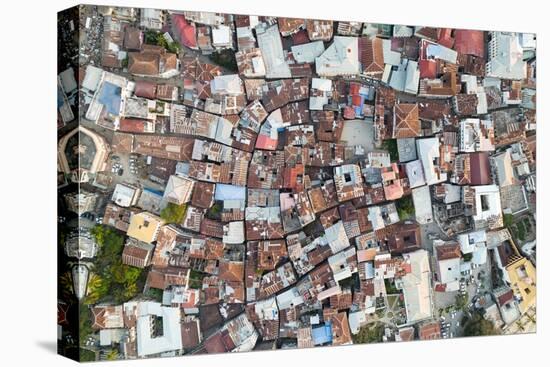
[57,5,537,361]
